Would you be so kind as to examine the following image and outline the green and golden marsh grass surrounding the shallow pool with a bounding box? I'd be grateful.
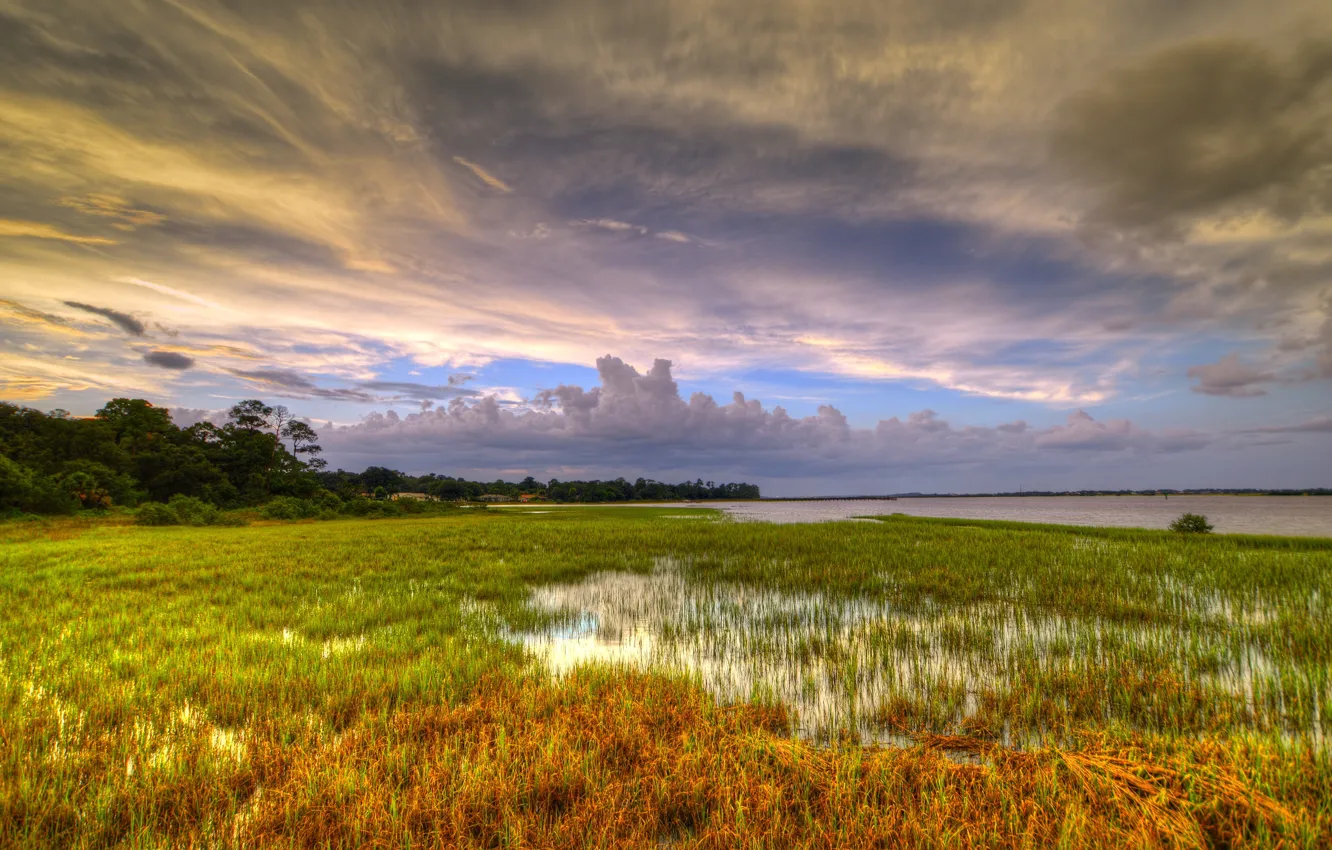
[0,508,1332,847]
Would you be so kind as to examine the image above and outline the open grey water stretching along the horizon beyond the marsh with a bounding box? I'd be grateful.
[703,496,1332,537]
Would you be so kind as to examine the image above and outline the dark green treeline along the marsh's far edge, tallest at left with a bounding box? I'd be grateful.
[0,398,759,521]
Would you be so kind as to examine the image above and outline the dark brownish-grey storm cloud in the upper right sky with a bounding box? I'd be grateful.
[1054,40,1332,225]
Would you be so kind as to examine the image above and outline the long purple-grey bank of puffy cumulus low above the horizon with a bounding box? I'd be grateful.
[321,356,1212,478]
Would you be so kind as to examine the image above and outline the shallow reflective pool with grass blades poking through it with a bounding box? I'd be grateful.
[513,559,1332,745]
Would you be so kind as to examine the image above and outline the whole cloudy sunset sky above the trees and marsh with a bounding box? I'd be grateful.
[0,0,1332,496]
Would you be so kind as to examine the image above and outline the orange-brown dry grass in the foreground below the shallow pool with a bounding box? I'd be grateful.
[229,673,1332,847]
